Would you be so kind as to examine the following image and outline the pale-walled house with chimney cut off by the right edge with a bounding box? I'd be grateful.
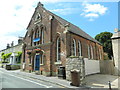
[111,29,120,75]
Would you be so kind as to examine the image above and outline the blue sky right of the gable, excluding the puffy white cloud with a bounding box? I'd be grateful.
[44,2,118,37]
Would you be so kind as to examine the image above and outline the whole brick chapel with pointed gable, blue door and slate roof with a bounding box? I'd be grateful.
[22,2,103,76]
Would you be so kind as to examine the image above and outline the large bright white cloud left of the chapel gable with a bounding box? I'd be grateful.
[0,0,39,50]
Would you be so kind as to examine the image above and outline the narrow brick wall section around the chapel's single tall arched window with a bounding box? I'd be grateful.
[51,18,66,73]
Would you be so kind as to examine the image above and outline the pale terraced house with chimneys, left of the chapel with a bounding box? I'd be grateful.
[0,37,23,64]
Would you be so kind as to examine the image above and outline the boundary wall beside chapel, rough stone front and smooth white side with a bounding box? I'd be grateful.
[66,58,100,81]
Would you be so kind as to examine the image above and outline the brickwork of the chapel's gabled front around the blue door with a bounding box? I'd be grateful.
[23,7,51,75]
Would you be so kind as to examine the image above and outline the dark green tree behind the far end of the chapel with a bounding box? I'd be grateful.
[95,32,113,59]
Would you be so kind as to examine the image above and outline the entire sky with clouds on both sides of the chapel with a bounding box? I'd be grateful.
[0,0,118,50]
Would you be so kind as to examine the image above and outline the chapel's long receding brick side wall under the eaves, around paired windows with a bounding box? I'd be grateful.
[66,33,103,60]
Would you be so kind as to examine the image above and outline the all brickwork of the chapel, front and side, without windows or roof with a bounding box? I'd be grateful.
[23,4,103,75]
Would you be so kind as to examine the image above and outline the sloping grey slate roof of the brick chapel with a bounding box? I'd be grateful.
[47,10,100,44]
